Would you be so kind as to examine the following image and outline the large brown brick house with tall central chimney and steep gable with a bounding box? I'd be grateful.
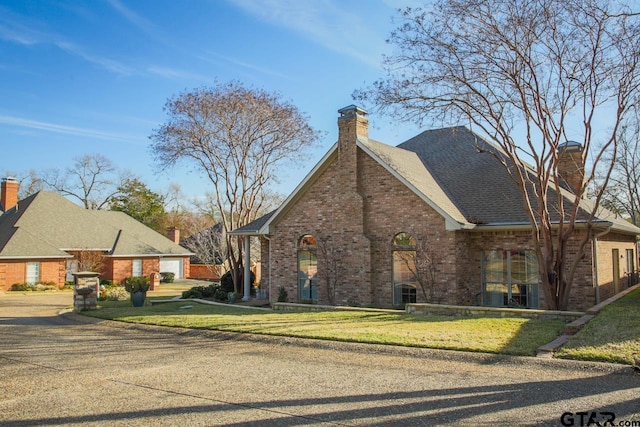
[232,106,640,310]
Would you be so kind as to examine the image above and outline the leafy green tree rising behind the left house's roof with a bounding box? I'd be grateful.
[109,178,164,234]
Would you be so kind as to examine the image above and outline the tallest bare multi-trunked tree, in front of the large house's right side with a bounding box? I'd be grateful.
[355,0,640,309]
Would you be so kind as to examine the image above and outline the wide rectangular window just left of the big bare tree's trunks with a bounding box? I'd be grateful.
[482,251,539,308]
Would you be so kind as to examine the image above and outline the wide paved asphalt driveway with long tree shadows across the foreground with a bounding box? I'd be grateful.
[0,293,640,426]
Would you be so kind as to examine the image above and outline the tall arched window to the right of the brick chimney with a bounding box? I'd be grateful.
[393,233,417,305]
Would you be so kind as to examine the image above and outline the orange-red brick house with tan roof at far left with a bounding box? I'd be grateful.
[0,178,191,290]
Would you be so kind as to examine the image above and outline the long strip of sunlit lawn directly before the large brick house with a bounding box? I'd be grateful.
[83,301,564,356]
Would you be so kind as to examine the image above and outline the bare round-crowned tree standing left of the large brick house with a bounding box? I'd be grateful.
[150,82,318,292]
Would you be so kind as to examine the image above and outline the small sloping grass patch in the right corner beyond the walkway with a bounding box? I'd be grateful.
[556,289,640,364]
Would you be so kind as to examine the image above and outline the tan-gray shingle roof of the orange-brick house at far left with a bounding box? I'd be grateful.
[0,191,190,258]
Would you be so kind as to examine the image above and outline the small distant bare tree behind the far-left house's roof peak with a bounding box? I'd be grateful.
[41,154,126,209]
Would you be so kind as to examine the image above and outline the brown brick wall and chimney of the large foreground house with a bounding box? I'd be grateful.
[261,108,637,310]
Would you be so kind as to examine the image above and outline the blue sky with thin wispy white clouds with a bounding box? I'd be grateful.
[0,0,419,203]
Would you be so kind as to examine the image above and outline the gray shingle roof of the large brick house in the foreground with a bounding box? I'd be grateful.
[232,126,640,234]
